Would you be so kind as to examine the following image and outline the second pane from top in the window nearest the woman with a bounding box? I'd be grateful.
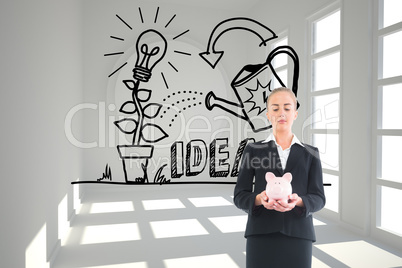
[313,52,340,91]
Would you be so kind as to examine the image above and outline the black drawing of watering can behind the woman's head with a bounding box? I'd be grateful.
[205,46,299,132]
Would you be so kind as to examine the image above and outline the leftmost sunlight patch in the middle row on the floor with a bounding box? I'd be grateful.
[80,223,141,244]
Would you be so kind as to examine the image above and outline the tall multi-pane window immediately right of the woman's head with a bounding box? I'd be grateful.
[303,4,342,213]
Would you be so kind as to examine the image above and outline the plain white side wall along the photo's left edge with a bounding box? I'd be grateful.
[0,0,82,267]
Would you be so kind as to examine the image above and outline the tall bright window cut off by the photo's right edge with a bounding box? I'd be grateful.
[373,0,402,234]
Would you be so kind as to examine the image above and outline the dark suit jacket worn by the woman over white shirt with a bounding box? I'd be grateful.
[234,141,325,242]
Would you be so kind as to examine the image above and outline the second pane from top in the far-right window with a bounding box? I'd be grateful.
[382,31,402,78]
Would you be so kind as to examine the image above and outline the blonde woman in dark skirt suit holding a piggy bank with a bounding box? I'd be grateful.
[234,88,325,268]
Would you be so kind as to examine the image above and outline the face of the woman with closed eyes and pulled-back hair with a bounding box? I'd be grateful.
[267,92,297,131]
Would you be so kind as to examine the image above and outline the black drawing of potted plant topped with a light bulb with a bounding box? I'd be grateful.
[114,29,168,183]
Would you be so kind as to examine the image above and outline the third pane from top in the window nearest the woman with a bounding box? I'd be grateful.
[313,93,339,129]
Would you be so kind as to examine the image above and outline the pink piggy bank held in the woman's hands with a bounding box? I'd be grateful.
[265,172,292,203]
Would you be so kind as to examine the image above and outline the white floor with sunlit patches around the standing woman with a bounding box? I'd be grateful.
[52,185,402,268]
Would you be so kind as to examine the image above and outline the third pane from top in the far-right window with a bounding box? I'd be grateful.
[382,84,402,129]
